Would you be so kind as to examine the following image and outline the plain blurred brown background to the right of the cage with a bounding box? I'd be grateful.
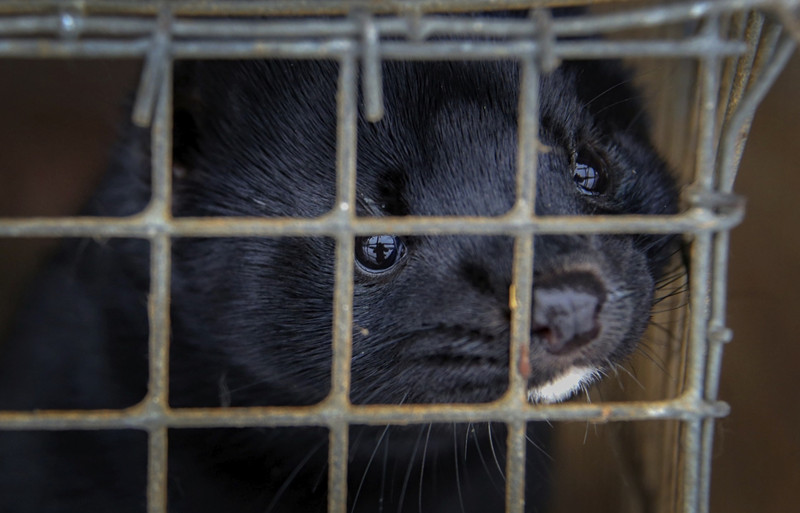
[711,53,800,513]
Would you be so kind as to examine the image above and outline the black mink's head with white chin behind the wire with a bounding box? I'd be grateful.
[161,61,676,405]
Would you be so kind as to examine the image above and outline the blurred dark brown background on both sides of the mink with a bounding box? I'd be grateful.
[0,36,800,513]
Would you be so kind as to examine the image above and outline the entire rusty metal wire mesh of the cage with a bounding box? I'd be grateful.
[0,0,797,512]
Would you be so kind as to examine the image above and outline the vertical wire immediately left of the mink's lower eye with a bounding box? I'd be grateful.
[328,48,357,513]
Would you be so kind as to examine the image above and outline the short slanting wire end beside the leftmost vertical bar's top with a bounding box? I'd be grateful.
[132,7,172,128]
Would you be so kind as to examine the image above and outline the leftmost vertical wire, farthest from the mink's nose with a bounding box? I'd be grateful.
[147,48,172,513]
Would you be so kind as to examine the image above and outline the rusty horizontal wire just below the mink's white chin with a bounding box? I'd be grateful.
[0,397,730,430]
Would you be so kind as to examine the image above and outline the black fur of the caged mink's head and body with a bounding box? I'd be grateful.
[0,56,676,512]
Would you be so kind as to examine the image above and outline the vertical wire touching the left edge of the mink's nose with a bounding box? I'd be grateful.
[506,51,539,513]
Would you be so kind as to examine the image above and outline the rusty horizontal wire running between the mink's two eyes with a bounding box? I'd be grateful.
[0,208,744,238]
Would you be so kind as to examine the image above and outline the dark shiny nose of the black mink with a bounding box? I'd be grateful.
[531,272,606,354]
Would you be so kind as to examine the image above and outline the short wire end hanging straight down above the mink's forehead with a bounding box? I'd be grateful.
[354,11,384,123]
